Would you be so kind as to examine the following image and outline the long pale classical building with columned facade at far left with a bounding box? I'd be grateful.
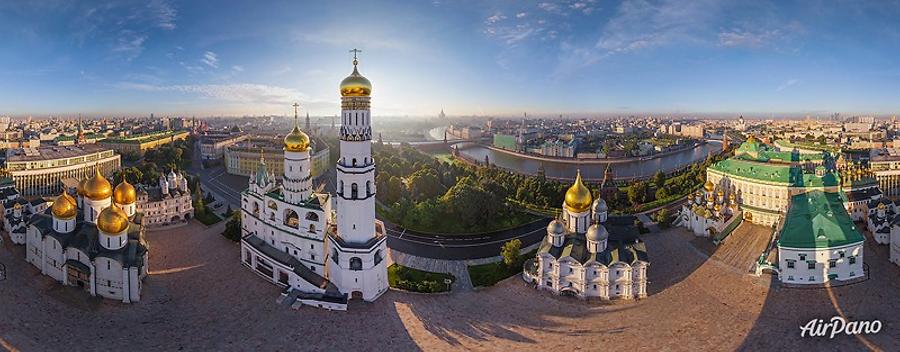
[6,144,121,197]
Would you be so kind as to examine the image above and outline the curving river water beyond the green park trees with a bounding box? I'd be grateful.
[429,129,722,180]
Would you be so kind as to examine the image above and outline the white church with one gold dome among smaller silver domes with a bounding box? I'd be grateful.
[522,173,650,300]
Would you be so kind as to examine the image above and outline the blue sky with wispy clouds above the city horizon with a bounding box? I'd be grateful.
[0,0,900,116]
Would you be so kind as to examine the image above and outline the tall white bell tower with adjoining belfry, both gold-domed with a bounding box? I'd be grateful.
[241,51,388,310]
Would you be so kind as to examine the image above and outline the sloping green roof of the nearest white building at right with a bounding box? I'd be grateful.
[778,191,863,248]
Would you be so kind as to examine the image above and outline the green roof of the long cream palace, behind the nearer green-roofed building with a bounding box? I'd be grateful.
[709,158,838,187]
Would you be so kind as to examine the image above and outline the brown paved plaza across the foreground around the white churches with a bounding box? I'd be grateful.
[0,223,900,351]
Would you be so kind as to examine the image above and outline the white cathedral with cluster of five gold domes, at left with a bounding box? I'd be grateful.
[25,169,149,303]
